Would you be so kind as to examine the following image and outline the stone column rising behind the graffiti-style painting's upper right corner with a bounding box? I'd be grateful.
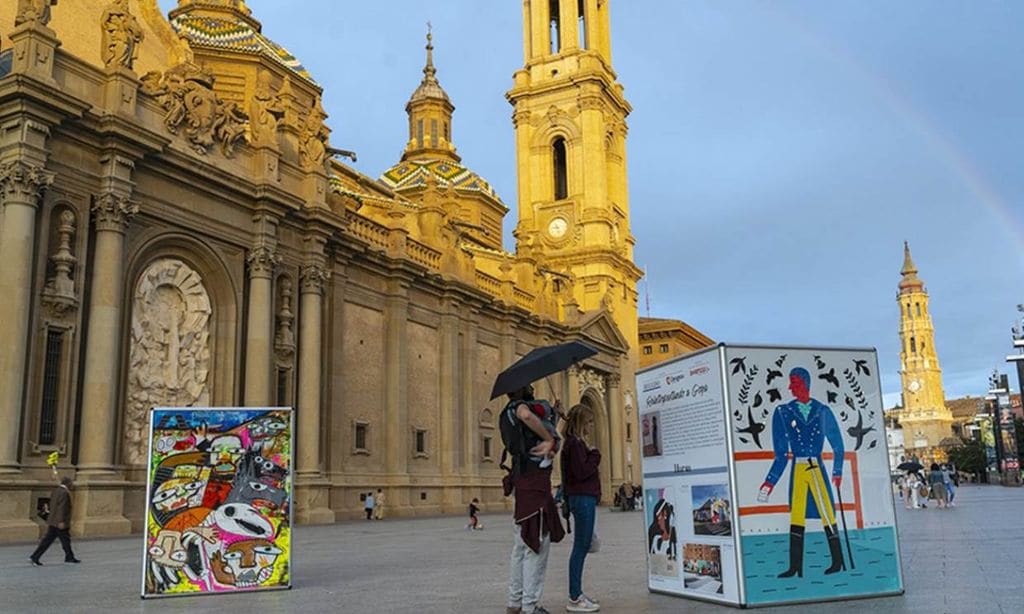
[245,215,281,407]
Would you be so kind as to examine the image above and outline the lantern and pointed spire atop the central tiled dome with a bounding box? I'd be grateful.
[401,23,460,162]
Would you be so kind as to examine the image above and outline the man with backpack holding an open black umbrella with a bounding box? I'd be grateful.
[490,342,597,614]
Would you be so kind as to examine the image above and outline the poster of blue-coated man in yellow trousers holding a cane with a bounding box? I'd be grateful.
[725,347,902,605]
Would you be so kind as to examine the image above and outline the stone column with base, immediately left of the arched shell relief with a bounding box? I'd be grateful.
[72,190,138,536]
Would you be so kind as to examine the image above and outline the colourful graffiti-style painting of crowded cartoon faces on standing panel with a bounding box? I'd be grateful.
[142,408,293,597]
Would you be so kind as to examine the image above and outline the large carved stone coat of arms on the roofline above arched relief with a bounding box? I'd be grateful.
[141,61,249,158]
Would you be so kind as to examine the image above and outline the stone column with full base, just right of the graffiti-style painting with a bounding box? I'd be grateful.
[295,255,334,523]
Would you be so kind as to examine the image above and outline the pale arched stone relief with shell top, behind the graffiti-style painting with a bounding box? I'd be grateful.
[124,258,212,464]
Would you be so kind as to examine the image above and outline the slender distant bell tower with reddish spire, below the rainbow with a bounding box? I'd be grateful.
[896,243,953,461]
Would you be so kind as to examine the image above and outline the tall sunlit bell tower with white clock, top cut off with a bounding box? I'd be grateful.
[507,0,641,349]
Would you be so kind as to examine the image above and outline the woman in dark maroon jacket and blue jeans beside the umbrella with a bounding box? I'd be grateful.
[561,405,601,612]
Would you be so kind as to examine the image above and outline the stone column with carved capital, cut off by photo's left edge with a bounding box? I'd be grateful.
[0,160,53,474]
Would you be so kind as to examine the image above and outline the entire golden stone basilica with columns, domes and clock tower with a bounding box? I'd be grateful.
[0,0,640,540]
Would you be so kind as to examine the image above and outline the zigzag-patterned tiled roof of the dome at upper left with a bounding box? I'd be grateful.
[171,13,315,83]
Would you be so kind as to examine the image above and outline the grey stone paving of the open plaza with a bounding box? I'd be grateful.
[0,486,1024,614]
